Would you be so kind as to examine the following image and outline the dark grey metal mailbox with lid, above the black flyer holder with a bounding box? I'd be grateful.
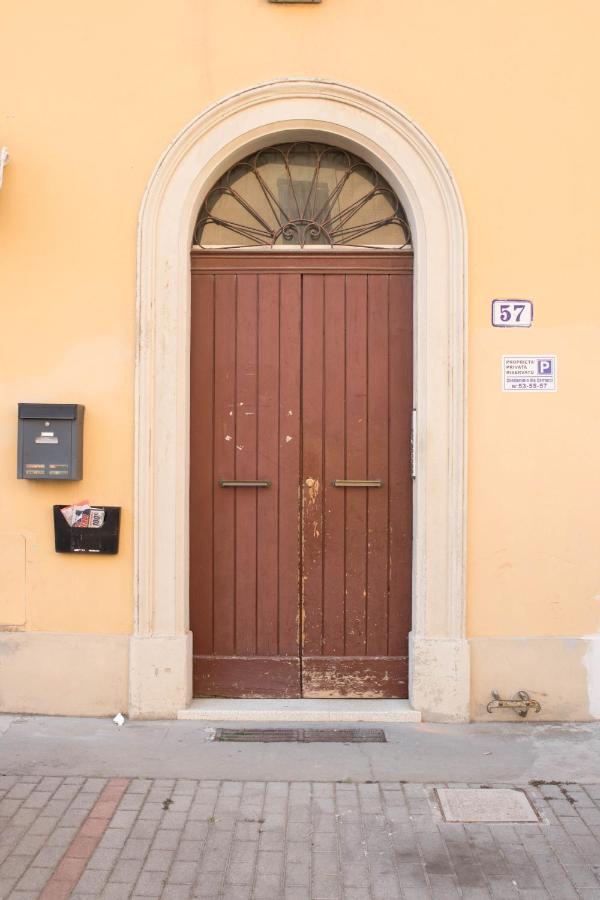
[17,403,84,481]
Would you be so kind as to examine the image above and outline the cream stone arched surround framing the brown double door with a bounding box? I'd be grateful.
[129,78,469,721]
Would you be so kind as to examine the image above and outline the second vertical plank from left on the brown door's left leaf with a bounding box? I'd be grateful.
[213,273,236,656]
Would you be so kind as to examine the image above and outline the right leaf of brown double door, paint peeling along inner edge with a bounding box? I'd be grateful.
[301,274,412,697]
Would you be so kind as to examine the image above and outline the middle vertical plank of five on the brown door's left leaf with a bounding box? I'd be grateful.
[230,274,258,656]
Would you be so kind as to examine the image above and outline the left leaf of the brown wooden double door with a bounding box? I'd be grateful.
[190,273,300,697]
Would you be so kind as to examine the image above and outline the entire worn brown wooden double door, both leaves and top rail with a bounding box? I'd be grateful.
[189,251,412,697]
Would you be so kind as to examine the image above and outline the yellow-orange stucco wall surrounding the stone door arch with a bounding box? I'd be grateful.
[0,0,600,712]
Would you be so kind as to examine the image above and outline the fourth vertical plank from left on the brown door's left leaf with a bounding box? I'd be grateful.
[255,274,279,656]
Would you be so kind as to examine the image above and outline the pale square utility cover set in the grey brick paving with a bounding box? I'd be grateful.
[436,788,539,822]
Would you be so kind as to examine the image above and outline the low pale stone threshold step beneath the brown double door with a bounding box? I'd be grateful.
[177,699,421,722]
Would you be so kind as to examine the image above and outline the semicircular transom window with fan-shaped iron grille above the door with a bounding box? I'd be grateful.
[194,143,410,248]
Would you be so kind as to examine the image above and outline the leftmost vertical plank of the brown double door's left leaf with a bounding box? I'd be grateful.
[190,273,215,653]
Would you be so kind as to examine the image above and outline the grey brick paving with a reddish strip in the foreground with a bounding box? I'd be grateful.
[0,775,600,900]
